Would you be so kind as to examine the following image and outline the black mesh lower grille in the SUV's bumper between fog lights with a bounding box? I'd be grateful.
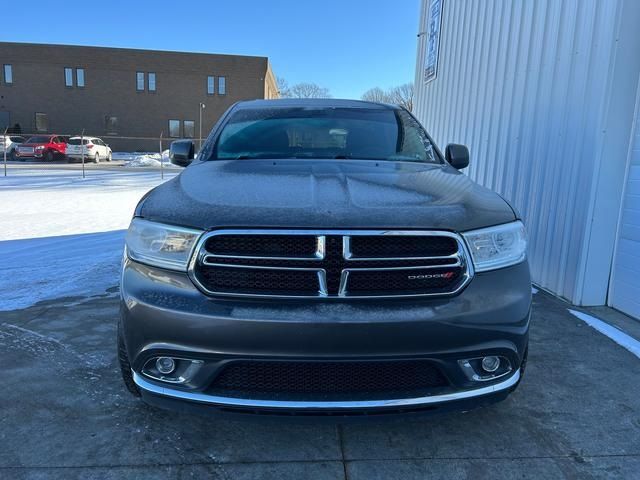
[207,360,449,401]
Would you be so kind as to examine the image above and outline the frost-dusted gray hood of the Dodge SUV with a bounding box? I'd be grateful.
[136,160,516,231]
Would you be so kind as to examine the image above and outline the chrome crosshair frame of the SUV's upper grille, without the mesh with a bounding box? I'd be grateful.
[188,229,474,299]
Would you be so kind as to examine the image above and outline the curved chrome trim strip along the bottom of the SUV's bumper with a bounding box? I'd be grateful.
[132,369,520,410]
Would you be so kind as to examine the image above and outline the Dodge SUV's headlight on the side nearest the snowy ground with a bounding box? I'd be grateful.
[126,218,202,271]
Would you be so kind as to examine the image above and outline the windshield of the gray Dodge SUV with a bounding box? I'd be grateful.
[209,107,440,163]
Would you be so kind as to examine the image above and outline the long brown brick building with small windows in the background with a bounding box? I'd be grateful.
[0,42,278,150]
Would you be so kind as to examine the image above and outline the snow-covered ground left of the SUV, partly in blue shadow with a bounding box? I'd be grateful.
[0,169,176,310]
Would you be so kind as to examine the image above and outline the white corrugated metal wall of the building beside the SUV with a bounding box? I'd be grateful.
[415,0,640,303]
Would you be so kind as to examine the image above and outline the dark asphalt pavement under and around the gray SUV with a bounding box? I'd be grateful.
[0,288,640,480]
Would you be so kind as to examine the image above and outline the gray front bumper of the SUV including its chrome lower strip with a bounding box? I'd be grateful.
[121,260,531,415]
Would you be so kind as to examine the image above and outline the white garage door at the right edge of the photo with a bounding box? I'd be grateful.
[609,97,640,319]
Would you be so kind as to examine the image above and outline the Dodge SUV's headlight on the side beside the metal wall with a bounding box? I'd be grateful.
[462,222,527,272]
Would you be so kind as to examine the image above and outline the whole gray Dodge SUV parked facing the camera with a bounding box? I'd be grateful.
[118,100,531,417]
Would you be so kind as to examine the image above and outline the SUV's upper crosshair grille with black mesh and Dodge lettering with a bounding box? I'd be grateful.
[190,230,472,298]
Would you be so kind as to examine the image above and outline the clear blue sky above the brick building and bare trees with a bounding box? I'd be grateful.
[0,0,420,98]
